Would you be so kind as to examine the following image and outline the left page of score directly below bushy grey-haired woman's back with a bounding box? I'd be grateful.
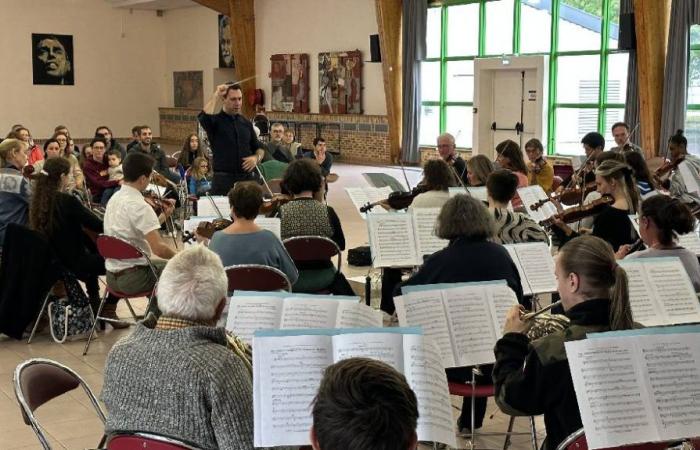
[394,290,458,367]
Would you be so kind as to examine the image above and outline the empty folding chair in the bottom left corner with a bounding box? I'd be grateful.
[13,358,106,449]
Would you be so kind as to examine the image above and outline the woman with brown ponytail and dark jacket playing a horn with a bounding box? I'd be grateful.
[493,236,633,450]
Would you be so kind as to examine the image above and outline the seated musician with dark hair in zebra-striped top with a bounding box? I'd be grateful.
[486,169,549,244]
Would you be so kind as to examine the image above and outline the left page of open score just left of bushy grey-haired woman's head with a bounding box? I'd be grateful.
[367,213,416,268]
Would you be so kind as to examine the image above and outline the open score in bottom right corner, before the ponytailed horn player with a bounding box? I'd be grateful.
[565,327,700,449]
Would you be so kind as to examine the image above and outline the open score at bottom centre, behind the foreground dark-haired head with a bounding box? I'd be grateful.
[253,328,457,447]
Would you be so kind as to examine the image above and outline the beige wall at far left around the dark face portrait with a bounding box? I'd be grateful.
[0,0,172,137]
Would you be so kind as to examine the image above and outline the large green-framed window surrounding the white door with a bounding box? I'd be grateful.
[420,0,628,154]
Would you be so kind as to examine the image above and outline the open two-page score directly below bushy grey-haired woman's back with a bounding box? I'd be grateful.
[394,281,518,367]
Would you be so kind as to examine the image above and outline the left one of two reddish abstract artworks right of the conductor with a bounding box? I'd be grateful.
[270,53,309,113]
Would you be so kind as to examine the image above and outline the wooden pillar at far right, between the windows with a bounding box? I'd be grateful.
[632,0,671,159]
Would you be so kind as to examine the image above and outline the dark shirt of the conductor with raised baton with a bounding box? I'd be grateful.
[197,110,264,174]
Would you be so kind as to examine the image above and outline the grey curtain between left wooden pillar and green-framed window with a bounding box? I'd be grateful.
[401,0,428,162]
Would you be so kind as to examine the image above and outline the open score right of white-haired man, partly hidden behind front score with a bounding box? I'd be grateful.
[225,291,382,343]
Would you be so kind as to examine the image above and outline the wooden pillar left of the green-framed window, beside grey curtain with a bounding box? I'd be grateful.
[375,0,403,162]
